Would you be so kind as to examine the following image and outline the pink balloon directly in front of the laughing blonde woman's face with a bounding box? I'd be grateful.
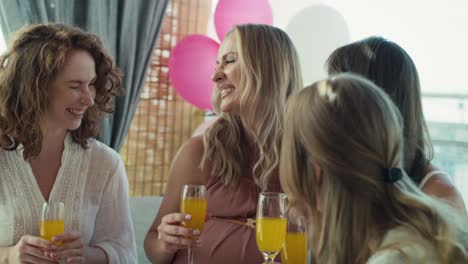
[169,35,219,110]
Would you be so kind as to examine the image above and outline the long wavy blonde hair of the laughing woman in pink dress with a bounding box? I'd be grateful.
[201,24,302,189]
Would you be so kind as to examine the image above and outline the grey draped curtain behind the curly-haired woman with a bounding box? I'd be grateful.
[0,0,169,151]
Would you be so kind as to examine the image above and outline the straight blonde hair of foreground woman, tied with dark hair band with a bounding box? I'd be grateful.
[280,74,468,263]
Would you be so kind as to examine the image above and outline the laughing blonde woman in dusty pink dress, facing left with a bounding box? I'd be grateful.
[145,25,302,264]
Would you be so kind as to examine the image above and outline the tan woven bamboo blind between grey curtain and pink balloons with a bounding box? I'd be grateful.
[120,0,211,196]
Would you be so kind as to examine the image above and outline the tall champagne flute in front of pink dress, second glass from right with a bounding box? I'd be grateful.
[255,192,287,263]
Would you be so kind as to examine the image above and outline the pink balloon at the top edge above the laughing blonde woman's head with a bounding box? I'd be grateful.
[214,0,273,41]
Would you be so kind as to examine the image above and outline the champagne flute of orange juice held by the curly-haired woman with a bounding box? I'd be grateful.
[40,202,65,246]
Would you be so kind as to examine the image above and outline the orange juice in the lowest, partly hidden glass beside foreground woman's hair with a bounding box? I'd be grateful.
[281,232,307,264]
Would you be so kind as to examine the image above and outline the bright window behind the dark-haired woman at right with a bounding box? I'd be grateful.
[270,0,468,204]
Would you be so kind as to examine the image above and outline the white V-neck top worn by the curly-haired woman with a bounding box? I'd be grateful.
[0,135,137,264]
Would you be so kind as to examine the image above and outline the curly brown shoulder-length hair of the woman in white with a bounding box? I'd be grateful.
[0,24,123,160]
